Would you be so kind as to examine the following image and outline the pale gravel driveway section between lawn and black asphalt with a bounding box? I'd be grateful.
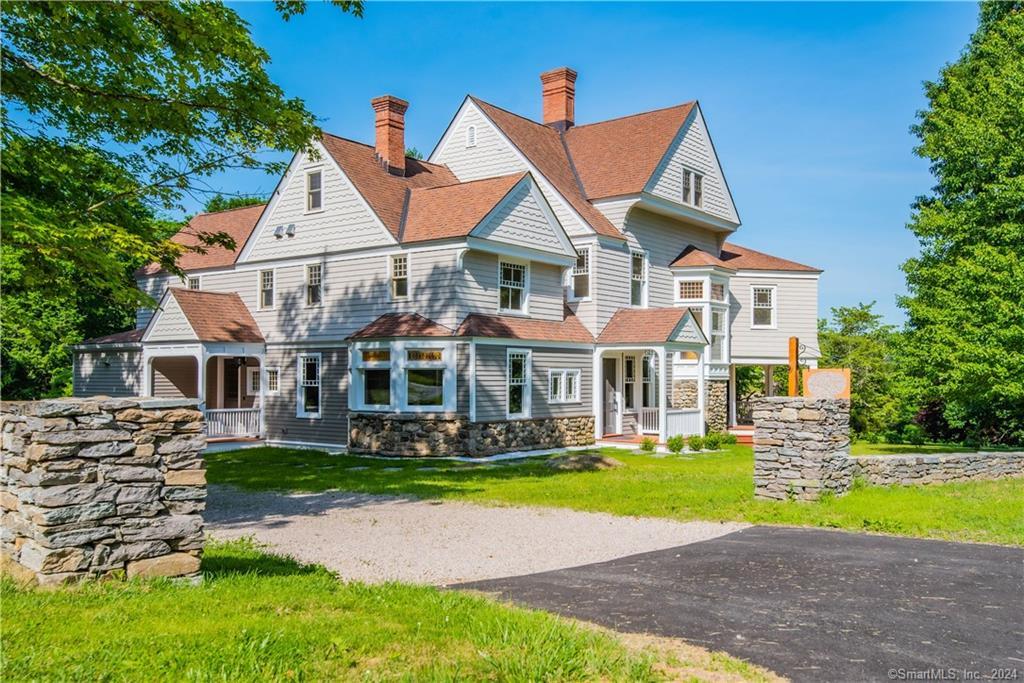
[206,486,748,585]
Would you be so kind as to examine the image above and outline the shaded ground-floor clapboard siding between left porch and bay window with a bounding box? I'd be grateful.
[264,346,348,445]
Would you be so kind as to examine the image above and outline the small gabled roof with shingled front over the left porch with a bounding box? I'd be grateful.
[142,287,264,343]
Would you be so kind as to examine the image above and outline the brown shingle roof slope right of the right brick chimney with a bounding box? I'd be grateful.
[565,102,694,200]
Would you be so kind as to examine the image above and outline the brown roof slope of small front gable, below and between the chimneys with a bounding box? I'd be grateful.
[401,172,526,243]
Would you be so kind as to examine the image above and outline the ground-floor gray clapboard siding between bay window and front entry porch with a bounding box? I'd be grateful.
[476,344,593,422]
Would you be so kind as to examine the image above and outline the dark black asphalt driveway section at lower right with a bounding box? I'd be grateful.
[458,526,1024,681]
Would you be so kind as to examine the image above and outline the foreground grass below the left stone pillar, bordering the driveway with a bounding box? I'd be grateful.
[0,541,770,681]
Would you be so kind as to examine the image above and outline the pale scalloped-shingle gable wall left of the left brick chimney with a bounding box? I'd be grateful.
[240,144,394,261]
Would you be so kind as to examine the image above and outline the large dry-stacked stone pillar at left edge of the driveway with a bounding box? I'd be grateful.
[0,396,206,585]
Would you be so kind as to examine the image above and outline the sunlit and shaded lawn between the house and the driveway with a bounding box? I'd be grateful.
[208,445,1024,545]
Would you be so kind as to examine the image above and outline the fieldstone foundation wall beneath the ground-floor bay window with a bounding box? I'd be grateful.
[348,413,594,457]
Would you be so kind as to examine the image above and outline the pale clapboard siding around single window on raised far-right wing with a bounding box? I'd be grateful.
[729,272,819,361]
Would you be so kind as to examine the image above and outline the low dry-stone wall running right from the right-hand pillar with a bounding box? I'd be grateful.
[850,452,1024,486]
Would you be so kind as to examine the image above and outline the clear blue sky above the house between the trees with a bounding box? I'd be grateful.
[218,3,977,323]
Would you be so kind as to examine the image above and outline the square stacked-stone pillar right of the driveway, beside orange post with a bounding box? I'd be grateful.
[754,396,853,501]
